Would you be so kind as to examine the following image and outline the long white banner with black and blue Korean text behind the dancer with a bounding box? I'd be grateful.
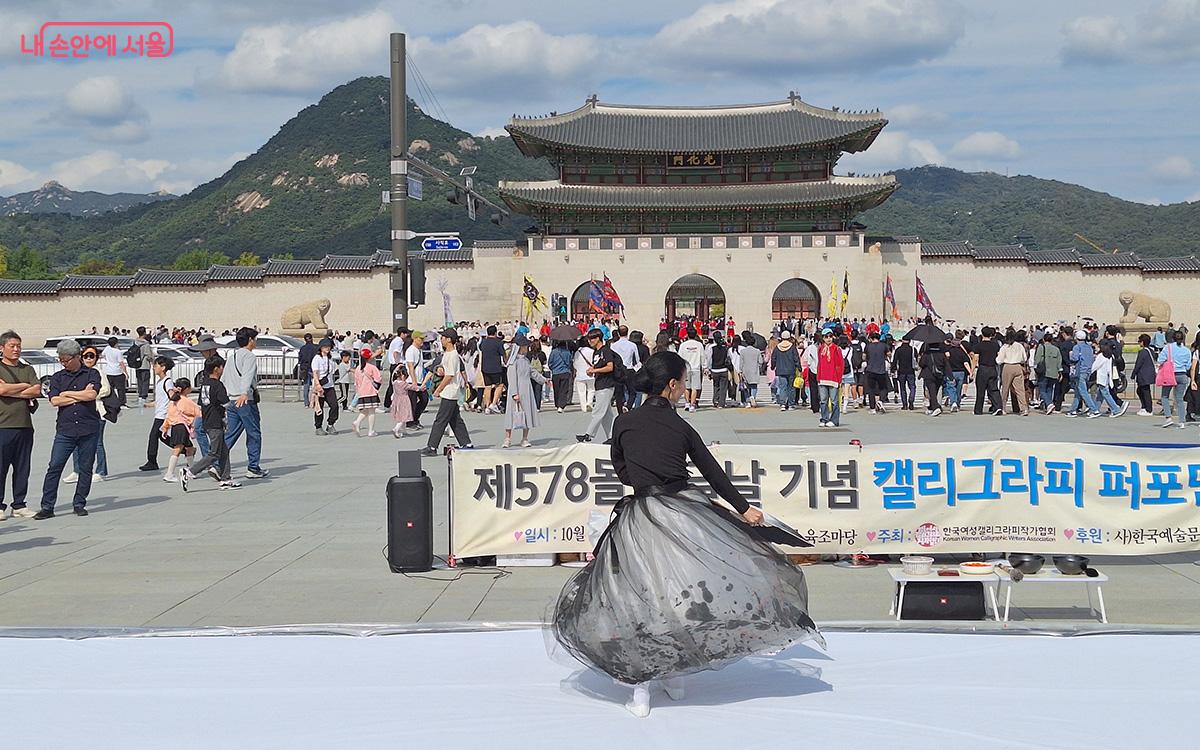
[450,440,1200,557]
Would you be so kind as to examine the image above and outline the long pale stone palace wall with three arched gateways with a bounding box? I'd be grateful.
[0,238,1200,344]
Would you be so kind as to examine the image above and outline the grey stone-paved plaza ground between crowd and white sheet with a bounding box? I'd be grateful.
[0,390,1200,626]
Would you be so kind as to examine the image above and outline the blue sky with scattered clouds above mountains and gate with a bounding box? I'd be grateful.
[0,0,1200,203]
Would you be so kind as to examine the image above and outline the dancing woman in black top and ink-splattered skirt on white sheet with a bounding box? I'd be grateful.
[551,352,824,716]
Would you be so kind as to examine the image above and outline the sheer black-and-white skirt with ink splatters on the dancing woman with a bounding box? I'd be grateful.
[550,490,824,684]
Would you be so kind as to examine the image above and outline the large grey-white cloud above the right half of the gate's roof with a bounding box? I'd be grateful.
[643,0,965,76]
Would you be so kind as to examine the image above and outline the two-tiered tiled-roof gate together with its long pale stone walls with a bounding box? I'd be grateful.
[0,94,1200,338]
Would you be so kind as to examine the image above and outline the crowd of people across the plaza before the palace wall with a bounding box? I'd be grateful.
[0,316,1200,520]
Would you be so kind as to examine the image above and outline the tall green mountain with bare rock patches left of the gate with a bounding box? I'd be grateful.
[0,77,553,268]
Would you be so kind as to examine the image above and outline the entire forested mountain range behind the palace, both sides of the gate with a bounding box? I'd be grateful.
[0,77,1200,268]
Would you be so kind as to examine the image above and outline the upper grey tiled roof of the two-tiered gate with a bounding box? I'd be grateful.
[504,95,888,156]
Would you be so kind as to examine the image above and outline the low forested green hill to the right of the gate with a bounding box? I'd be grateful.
[859,167,1200,256]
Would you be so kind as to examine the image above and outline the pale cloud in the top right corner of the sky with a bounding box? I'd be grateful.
[1062,0,1200,65]
